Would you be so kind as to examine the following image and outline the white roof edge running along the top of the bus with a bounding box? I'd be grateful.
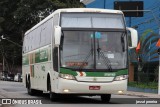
[25,8,123,35]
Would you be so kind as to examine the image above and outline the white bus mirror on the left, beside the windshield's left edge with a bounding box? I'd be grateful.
[54,26,61,46]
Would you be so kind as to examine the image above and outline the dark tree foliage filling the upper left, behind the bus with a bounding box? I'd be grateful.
[0,0,83,72]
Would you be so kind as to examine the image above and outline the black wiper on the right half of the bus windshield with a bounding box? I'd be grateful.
[97,39,112,71]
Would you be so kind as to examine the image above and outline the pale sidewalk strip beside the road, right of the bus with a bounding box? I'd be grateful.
[125,91,160,98]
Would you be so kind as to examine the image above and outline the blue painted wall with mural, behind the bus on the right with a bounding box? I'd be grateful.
[86,0,160,62]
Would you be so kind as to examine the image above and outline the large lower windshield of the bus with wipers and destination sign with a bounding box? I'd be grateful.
[60,31,127,70]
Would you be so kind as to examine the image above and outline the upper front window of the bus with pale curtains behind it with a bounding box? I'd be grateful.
[61,13,125,29]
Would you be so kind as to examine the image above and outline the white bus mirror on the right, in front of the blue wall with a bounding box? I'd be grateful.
[127,27,138,49]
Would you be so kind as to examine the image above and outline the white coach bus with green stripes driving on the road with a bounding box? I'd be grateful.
[22,8,137,102]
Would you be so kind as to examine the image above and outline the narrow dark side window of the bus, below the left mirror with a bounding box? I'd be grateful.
[53,47,58,72]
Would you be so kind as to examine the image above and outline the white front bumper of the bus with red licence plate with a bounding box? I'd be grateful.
[55,78,127,95]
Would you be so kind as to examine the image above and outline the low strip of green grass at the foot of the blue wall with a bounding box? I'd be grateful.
[128,82,158,89]
